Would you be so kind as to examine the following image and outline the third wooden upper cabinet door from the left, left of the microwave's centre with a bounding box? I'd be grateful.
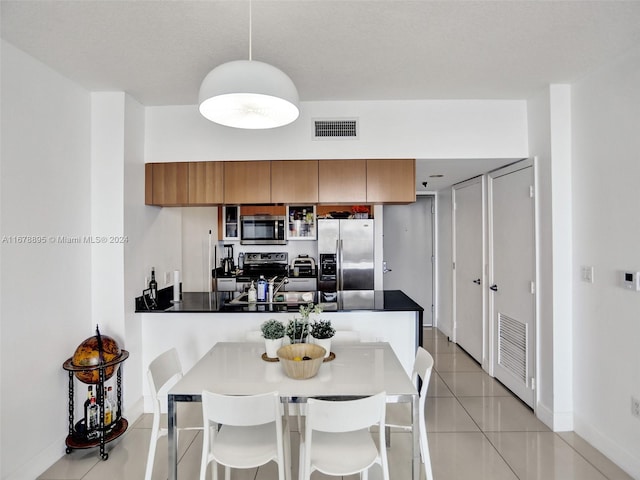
[224,161,271,204]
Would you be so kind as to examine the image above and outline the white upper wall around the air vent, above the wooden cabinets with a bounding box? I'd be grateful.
[145,100,527,162]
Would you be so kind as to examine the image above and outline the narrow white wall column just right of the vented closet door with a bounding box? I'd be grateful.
[528,85,573,431]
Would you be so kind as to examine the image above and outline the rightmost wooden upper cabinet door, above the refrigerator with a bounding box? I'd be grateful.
[367,159,416,203]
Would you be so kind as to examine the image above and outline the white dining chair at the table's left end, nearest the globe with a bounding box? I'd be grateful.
[144,348,202,480]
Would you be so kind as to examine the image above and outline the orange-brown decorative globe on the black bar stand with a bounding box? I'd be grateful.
[71,335,120,384]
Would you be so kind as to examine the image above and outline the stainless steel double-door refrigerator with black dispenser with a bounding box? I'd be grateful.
[318,219,374,292]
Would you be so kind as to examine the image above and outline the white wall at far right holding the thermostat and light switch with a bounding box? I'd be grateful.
[559,44,640,478]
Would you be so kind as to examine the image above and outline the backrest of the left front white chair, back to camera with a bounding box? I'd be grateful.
[202,390,281,427]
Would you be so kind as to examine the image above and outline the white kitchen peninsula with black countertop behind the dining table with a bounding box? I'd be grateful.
[137,290,424,386]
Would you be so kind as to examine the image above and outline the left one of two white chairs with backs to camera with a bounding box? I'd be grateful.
[200,391,291,480]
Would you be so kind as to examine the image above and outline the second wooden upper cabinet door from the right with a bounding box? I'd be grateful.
[318,160,367,203]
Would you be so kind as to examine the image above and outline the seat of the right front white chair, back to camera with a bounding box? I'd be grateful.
[311,429,378,476]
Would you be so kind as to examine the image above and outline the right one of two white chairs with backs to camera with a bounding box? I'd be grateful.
[300,392,389,480]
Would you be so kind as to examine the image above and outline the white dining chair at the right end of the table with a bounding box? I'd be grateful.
[386,347,433,480]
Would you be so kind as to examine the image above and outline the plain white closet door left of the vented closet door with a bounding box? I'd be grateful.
[453,177,485,364]
